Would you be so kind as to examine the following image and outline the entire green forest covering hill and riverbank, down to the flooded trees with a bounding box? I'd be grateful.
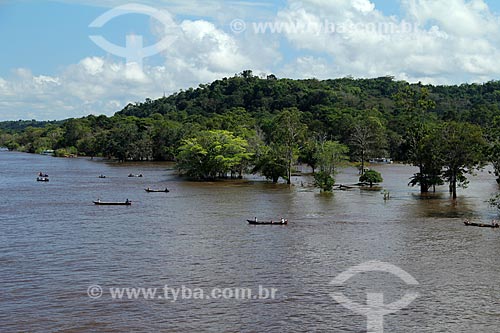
[0,70,500,194]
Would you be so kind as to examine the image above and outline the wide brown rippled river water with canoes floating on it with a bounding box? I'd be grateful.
[0,152,500,332]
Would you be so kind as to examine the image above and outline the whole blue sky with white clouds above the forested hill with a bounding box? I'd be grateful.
[0,0,500,121]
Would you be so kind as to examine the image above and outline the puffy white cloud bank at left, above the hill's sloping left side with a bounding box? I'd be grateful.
[0,12,265,119]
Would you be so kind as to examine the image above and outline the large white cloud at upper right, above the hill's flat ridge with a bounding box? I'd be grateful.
[277,0,500,83]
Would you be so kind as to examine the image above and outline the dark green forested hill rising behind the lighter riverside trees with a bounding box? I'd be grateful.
[117,71,500,126]
